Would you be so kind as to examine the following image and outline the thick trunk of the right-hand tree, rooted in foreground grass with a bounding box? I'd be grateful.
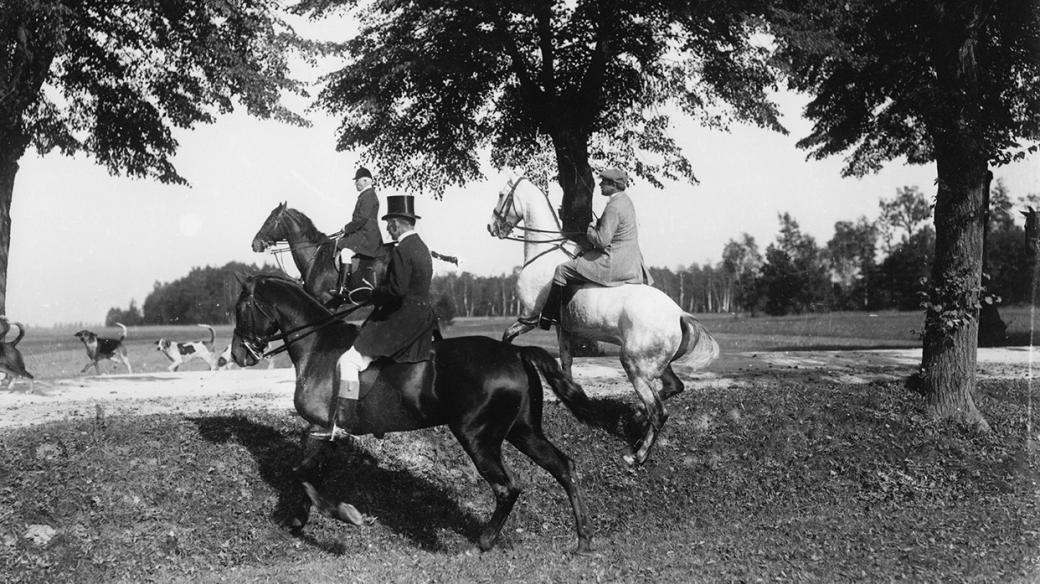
[920,152,989,431]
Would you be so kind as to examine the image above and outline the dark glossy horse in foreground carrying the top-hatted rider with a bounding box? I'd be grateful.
[231,275,596,551]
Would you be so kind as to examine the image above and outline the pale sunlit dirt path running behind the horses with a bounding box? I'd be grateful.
[0,347,1040,428]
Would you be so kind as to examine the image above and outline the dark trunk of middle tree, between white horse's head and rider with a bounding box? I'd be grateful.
[552,132,596,239]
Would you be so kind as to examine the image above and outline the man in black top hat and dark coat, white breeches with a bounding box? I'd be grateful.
[339,195,437,417]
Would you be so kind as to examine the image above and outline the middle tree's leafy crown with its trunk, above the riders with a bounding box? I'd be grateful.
[295,0,782,233]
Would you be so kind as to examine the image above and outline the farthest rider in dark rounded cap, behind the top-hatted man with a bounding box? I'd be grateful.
[331,166,383,296]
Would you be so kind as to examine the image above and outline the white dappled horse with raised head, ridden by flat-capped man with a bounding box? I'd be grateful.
[488,172,719,464]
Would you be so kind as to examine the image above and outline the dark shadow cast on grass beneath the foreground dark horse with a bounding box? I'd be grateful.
[189,416,483,555]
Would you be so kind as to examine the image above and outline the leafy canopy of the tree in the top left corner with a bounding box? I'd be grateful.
[0,0,304,183]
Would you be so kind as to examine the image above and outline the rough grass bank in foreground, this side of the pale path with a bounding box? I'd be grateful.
[0,374,1040,583]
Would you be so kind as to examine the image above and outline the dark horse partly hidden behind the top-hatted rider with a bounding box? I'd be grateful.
[253,203,389,306]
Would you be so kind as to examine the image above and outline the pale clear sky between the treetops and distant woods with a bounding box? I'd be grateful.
[7,20,1040,326]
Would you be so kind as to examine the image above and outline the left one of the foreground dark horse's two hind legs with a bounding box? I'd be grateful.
[451,420,520,552]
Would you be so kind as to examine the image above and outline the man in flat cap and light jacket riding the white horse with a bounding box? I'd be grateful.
[539,167,653,330]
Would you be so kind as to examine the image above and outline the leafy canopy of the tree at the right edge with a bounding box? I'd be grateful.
[772,0,1040,176]
